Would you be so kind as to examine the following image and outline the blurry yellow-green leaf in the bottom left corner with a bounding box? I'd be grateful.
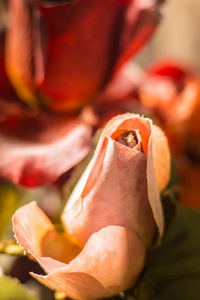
[0,276,39,300]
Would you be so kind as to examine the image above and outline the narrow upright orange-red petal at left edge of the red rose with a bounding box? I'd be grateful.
[5,0,45,106]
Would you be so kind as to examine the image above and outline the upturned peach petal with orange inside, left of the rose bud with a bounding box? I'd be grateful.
[13,202,81,272]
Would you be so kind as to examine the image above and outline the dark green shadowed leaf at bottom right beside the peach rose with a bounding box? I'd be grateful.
[136,206,200,300]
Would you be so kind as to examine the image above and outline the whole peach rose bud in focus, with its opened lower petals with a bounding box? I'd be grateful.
[13,114,170,299]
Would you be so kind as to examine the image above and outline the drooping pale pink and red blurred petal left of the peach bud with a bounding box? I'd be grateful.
[0,113,91,187]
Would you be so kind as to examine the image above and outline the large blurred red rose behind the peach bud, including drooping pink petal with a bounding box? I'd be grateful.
[0,0,163,186]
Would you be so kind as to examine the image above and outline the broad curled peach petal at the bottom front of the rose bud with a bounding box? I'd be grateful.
[32,226,145,299]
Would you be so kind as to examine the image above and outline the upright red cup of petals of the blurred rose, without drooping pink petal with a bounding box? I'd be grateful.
[6,0,163,110]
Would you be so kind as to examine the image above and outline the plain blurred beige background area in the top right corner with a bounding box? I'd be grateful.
[137,0,200,73]
